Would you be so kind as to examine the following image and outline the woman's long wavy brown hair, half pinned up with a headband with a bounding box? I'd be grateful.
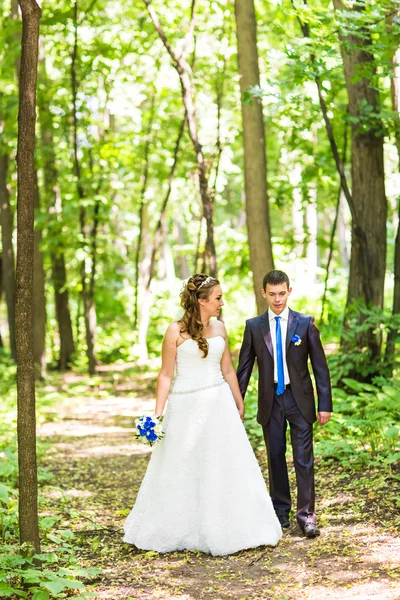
[179,273,219,358]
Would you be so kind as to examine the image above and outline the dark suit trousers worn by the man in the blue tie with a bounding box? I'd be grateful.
[263,389,317,529]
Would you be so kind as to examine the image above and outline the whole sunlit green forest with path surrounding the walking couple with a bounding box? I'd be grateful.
[0,0,400,600]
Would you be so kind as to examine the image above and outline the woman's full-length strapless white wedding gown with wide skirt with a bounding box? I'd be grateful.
[124,336,282,555]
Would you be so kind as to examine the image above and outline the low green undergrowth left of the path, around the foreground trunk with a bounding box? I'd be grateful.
[0,358,100,600]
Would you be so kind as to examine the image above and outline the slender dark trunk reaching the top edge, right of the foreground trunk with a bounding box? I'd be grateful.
[71,0,96,375]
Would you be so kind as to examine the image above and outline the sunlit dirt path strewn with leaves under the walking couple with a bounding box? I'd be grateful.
[39,372,400,600]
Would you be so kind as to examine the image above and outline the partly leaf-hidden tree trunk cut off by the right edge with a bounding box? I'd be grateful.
[385,39,400,368]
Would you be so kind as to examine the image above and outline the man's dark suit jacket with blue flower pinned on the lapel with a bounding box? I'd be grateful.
[237,309,332,425]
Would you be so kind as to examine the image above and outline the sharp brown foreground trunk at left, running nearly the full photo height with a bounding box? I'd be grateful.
[15,0,41,552]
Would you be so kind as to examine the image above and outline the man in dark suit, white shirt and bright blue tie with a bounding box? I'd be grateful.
[237,270,332,538]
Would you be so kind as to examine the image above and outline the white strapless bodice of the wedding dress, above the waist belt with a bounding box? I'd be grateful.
[173,335,225,392]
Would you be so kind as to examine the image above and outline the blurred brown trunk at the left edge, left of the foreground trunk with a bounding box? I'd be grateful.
[0,152,17,359]
